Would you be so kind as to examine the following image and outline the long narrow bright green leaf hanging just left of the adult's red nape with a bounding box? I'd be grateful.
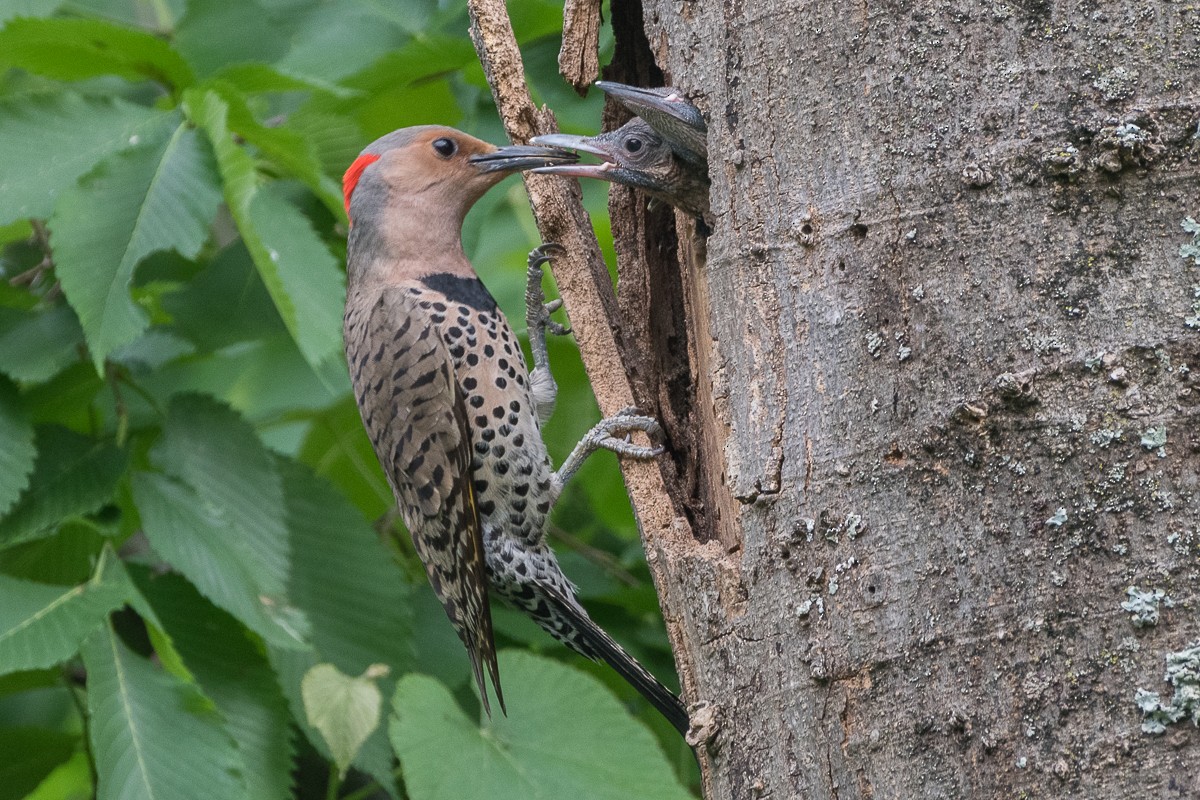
[185,91,346,368]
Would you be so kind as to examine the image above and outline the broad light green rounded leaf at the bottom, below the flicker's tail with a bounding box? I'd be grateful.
[389,651,691,800]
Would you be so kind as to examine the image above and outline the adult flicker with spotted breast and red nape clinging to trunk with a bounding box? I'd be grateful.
[343,126,688,732]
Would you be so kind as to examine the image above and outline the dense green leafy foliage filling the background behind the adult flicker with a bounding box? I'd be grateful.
[0,0,695,800]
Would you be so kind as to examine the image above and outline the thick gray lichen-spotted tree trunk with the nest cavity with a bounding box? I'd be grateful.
[605,0,1200,800]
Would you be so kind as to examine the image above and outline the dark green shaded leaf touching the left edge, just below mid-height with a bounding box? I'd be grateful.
[0,426,126,547]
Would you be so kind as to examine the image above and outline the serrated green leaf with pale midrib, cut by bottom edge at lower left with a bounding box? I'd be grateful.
[82,625,250,800]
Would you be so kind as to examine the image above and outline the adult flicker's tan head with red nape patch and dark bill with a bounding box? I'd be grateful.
[342,125,577,225]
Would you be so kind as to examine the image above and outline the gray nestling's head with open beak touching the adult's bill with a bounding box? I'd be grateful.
[532,118,708,217]
